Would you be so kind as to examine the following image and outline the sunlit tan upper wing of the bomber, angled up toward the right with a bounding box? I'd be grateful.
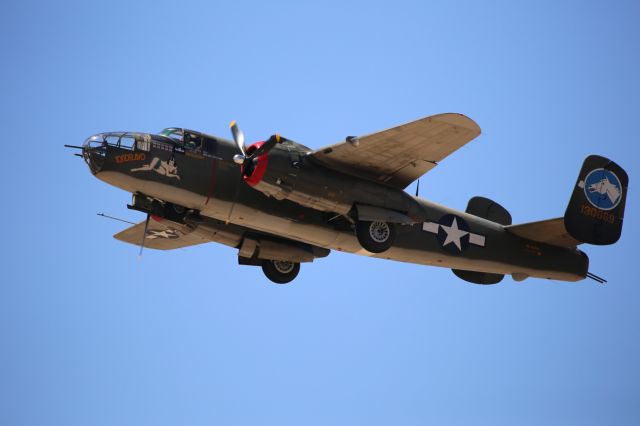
[309,114,480,188]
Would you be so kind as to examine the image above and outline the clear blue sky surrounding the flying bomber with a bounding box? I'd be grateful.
[0,0,640,426]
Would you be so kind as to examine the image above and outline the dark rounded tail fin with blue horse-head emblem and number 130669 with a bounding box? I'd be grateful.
[564,155,629,245]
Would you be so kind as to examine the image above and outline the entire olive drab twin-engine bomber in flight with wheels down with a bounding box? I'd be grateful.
[67,113,629,284]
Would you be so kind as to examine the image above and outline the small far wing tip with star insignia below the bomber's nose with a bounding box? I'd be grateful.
[113,219,209,250]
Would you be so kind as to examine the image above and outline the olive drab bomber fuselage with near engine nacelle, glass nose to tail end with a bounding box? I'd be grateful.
[83,131,588,281]
